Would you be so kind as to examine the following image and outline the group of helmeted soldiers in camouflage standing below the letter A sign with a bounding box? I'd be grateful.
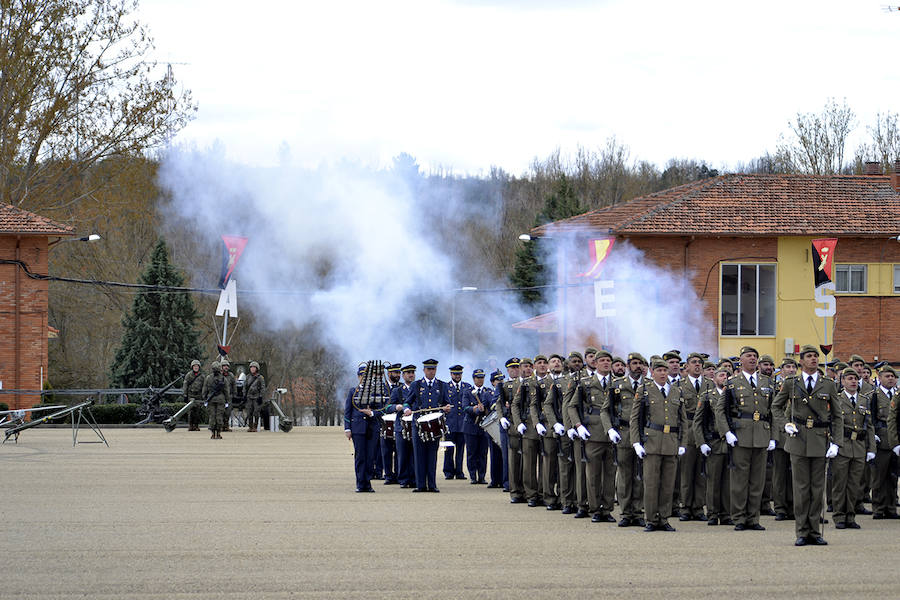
[181,357,266,440]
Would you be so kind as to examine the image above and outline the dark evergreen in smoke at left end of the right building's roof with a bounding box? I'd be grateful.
[509,175,584,308]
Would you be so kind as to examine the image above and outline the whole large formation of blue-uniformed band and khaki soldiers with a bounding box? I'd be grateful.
[344,345,900,546]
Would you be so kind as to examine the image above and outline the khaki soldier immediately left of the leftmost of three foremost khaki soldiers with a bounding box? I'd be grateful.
[600,352,647,527]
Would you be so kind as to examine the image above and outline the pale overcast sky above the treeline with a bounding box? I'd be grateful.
[140,0,900,174]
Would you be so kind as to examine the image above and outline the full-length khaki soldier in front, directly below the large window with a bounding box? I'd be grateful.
[716,346,775,531]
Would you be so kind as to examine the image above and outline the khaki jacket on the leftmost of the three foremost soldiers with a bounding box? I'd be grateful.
[631,380,690,456]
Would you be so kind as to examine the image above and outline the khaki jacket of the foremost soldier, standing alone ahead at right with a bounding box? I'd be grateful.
[772,372,844,456]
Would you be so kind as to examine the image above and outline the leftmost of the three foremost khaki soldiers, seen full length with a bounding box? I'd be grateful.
[630,360,689,531]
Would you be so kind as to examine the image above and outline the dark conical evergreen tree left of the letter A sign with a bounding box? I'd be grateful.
[110,239,203,388]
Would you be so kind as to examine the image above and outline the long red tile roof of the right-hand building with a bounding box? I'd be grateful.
[532,174,900,237]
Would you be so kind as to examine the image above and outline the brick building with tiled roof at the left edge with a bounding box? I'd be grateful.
[0,203,72,409]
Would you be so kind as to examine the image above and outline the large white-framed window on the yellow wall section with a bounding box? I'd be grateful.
[721,265,775,336]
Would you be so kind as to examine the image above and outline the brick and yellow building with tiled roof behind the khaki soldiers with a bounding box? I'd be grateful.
[516,161,900,362]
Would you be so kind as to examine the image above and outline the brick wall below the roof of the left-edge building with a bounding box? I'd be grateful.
[0,235,47,408]
